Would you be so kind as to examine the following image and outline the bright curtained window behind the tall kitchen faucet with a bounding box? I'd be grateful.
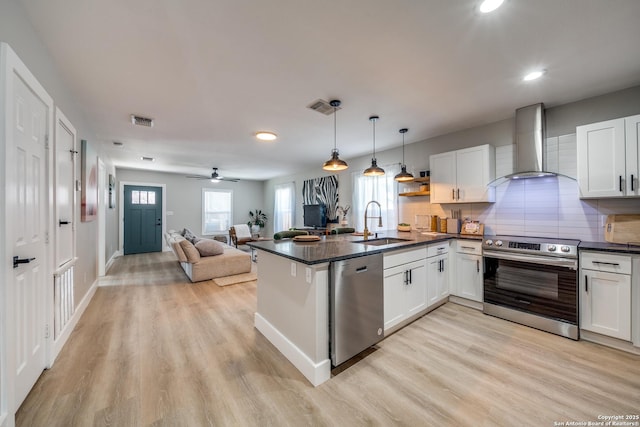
[352,165,400,233]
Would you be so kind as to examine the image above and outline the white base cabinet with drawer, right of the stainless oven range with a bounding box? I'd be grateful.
[580,251,631,341]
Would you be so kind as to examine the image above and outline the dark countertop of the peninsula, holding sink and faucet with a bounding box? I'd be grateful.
[248,230,482,265]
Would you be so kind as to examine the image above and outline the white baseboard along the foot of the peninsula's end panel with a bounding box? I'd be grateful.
[254,313,331,387]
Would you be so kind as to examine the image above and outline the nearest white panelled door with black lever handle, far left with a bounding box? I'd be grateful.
[2,45,53,414]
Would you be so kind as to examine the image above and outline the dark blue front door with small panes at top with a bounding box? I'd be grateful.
[124,185,162,255]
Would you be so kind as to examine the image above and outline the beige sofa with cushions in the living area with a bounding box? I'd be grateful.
[165,231,251,282]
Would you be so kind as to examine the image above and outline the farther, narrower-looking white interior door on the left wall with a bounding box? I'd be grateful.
[54,109,77,268]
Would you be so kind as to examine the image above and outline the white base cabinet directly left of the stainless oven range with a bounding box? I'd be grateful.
[451,240,484,302]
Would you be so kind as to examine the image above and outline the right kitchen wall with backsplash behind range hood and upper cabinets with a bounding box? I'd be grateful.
[265,86,640,241]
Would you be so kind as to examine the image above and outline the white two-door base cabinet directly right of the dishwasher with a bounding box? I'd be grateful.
[384,248,427,331]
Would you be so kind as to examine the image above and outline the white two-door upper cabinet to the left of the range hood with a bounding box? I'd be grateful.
[429,144,496,203]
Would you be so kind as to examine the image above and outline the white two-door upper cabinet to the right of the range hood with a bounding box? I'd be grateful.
[576,115,640,198]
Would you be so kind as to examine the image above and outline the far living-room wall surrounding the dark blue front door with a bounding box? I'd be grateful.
[116,168,264,241]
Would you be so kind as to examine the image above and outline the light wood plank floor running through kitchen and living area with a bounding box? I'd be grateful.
[17,254,640,426]
